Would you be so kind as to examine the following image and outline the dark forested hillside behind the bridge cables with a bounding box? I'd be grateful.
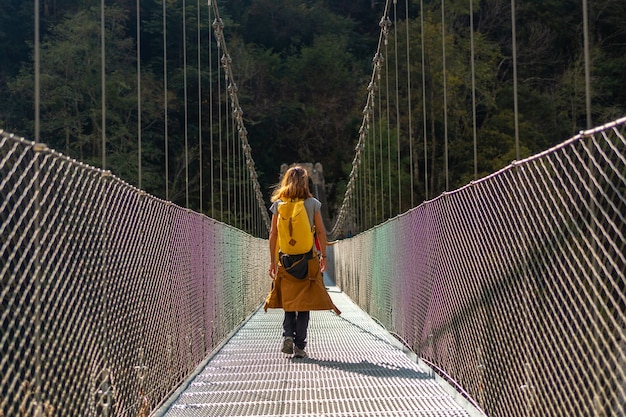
[0,0,626,228]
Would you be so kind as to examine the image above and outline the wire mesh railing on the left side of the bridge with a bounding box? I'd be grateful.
[0,131,267,416]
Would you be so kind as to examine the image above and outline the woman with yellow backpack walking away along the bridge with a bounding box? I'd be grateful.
[264,166,341,358]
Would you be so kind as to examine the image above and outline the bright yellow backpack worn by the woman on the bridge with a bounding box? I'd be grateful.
[278,199,313,255]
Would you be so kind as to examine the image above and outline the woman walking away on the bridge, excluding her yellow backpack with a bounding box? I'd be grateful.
[265,166,341,358]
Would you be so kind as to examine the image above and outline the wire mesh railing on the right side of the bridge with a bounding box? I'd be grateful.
[332,118,626,417]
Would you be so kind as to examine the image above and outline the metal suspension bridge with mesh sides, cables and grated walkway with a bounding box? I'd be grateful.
[0,1,626,417]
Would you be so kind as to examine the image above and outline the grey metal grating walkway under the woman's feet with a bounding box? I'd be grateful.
[155,287,482,417]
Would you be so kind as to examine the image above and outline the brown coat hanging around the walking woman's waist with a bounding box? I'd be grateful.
[263,256,341,314]
